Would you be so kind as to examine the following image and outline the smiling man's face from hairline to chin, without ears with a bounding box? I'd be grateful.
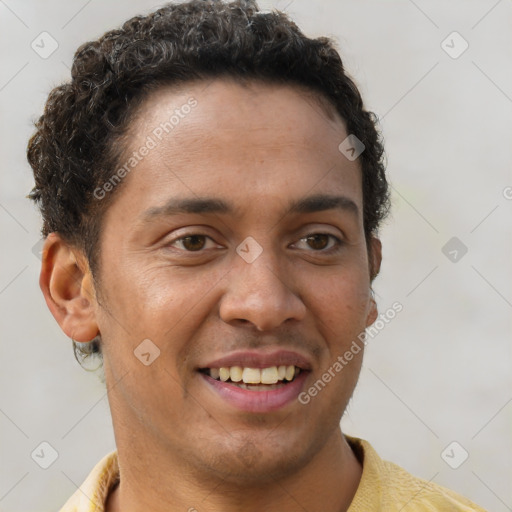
[90,80,376,481]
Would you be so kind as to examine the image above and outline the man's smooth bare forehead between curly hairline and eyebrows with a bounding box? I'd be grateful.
[110,79,362,220]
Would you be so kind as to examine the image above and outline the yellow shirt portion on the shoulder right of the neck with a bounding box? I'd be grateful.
[347,437,485,512]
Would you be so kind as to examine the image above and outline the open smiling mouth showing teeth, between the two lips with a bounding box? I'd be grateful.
[199,365,301,391]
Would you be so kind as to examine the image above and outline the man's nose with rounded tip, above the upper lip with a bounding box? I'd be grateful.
[220,251,306,331]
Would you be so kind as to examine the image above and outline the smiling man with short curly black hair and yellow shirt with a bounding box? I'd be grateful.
[28,0,482,512]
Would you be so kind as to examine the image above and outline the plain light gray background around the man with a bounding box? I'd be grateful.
[0,0,512,512]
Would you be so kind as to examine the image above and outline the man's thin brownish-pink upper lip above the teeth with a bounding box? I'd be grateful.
[200,350,312,370]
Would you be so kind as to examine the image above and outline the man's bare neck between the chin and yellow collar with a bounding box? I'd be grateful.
[105,429,362,512]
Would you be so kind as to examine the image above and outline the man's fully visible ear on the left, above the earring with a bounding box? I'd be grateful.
[39,233,99,342]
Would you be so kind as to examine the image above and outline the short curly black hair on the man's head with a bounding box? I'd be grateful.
[27,0,390,368]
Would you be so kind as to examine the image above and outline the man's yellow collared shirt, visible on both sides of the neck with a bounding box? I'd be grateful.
[60,436,485,512]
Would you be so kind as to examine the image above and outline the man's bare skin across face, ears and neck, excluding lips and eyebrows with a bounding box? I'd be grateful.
[40,79,381,512]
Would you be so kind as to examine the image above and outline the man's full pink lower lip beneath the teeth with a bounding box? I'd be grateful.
[201,371,309,412]
